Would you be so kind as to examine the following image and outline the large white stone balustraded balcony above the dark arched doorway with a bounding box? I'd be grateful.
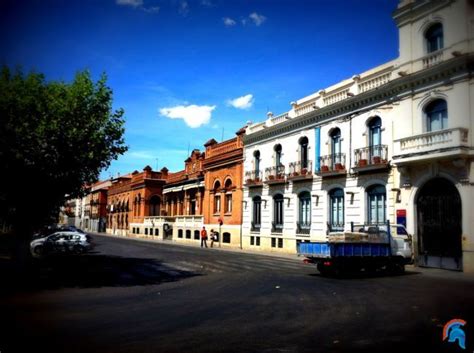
[393,128,469,165]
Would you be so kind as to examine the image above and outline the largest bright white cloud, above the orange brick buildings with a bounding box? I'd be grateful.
[160,104,216,128]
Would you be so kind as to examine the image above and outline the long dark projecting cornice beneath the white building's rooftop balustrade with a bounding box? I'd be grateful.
[244,54,474,146]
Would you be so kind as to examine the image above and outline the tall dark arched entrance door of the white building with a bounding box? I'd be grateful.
[416,178,462,270]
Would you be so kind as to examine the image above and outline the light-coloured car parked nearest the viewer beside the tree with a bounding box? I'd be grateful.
[30,231,93,257]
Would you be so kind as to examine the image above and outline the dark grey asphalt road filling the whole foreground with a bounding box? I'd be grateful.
[0,236,474,353]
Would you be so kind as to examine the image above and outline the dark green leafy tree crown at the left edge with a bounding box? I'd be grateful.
[0,67,127,232]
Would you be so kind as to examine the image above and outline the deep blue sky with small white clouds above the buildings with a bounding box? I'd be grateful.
[0,0,398,178]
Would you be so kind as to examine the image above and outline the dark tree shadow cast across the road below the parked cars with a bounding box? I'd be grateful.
[0,254,199,294]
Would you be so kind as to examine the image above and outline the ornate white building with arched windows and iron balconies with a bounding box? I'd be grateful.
[243,0,474,272]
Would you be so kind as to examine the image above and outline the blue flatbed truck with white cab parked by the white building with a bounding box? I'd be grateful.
[297,222,413,276]
